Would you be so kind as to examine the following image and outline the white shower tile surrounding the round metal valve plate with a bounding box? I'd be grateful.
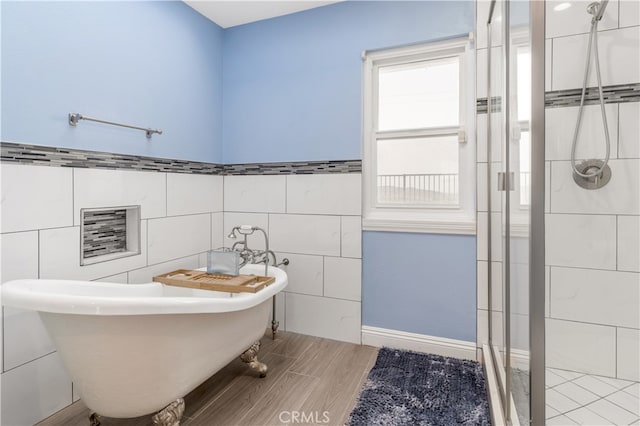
[551,160,640,215]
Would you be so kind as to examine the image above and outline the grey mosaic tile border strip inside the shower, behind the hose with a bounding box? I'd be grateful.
[476,83,640,114]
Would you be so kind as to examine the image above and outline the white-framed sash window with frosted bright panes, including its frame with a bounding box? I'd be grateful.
[363,39,475,234]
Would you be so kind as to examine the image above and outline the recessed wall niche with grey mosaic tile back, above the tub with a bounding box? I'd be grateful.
[80,206,140,265]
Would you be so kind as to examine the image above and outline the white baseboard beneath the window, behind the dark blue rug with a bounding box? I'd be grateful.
[362,325,477,360]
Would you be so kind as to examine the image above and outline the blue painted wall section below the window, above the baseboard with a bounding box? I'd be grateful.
[362,232,476,342]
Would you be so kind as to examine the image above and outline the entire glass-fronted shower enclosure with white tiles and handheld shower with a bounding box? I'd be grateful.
[478,0,640,425]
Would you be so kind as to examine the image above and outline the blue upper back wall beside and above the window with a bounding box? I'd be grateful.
[223,1,474,163]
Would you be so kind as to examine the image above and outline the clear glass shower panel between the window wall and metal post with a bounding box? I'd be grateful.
[487,0,531,424]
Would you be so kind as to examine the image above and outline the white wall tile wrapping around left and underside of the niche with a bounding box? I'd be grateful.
[39,225,147,281]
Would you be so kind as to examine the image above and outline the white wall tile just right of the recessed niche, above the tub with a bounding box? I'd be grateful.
[148,214,211,269]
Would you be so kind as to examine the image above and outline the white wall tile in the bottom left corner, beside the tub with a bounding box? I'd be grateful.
[2,353,72,425]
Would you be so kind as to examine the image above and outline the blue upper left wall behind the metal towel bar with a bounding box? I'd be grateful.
[0,1,223,162]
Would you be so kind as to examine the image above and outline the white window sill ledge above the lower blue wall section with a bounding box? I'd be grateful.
[362,217,476,235]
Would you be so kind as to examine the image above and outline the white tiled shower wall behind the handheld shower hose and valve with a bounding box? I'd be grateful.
[545,0,640,382]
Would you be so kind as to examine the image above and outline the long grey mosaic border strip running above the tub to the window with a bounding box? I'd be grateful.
[0,142,362,175]
